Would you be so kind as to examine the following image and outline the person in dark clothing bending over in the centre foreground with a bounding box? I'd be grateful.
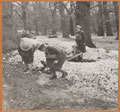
[39,44,67,79]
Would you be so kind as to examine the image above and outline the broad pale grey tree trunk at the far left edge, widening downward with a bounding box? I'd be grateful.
[2,2,20,52]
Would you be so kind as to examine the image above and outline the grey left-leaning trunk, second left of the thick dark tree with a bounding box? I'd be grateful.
[59,2,69,38]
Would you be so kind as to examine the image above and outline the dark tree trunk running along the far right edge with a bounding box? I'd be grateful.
[113,1,119,40]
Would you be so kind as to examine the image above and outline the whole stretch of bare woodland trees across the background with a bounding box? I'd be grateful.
[2,1,119,49]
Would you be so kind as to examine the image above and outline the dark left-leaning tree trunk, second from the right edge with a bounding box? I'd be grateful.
[103,2,113,36]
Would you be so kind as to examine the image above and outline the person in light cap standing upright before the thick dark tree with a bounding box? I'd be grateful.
[75,25,86,61]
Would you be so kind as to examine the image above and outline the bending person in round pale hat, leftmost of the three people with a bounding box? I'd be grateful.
[18,38,41,71]
